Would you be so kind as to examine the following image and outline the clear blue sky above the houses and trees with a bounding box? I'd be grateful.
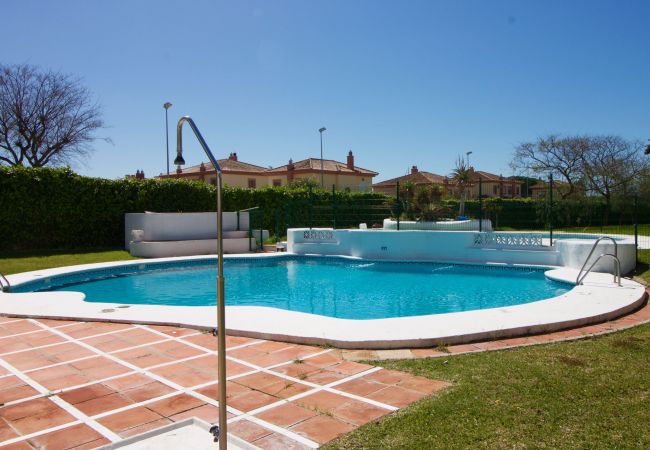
[0,0,650,181]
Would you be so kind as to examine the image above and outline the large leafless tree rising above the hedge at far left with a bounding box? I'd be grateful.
[0,64,104,167]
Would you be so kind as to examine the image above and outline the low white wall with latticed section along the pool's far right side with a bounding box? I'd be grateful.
[287,228,636,274]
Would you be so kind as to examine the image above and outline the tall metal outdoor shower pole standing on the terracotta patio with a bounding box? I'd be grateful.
[174,116,228,450]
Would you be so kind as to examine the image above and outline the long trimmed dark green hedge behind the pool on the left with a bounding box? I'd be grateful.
[0,167,389,251]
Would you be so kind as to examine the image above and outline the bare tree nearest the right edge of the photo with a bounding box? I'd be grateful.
[583,136,648,207]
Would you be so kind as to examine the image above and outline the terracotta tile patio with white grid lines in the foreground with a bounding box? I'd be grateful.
[0,317,447,449]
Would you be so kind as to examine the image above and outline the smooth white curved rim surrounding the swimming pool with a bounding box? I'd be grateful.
[0,253,645,349]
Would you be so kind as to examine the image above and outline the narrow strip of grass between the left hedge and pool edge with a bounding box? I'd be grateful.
[0,249,135,275]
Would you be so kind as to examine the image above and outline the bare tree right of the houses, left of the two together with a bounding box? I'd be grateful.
[510,135,589,198]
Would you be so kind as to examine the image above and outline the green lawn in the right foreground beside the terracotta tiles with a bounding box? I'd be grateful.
[326,250,650,449]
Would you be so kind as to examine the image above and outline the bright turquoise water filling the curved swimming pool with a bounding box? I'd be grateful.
[22,257,571,319]
